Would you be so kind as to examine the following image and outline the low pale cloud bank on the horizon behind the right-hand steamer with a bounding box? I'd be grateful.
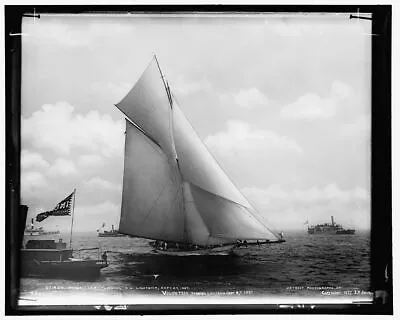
[242,183,370,229]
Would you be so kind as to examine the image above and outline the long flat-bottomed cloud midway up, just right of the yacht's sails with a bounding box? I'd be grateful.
[204,120,302,153]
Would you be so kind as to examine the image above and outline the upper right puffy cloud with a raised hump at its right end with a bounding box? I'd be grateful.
[281,81,353,120]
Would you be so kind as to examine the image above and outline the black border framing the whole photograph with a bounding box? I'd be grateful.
[4,5,393,315]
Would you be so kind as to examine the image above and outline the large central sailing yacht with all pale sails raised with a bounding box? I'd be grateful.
[116,56,284,255]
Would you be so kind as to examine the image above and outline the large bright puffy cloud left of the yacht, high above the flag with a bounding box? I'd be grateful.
[21,102,124,157]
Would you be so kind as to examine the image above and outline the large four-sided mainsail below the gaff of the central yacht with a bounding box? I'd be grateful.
[119,121,185,242]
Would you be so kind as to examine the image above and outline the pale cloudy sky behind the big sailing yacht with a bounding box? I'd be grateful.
[21,14,371,232]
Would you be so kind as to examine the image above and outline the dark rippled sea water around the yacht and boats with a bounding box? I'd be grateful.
[20,232,372,305]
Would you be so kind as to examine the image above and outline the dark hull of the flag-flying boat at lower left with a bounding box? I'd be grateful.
[22,260,108,280]
